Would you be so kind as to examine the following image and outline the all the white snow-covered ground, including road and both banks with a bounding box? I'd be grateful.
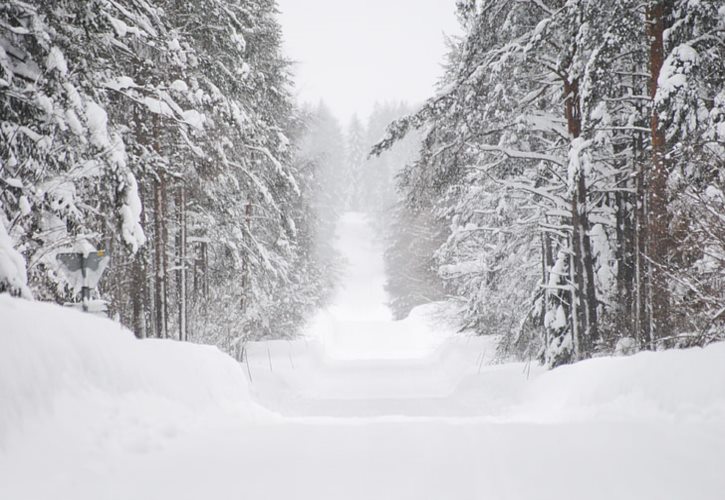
[0,214,725,500]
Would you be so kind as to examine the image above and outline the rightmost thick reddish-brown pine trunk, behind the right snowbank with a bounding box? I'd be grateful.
[647,0,671,340]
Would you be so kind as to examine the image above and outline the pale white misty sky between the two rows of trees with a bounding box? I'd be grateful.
[278,0,459,122]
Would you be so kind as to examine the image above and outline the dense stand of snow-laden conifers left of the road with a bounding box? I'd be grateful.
[0,0,330,351]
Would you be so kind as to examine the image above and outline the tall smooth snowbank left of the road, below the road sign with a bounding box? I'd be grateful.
[0,295,253,447]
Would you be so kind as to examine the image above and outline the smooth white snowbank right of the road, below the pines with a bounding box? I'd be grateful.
[517,342,725,423]
